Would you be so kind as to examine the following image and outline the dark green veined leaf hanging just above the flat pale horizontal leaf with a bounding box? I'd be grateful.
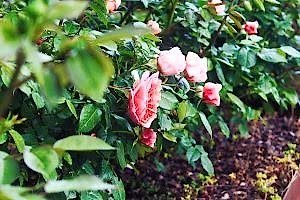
[79,104,102,132]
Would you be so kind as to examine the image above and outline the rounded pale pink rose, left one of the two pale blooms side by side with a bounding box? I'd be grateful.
[157,47,185,76]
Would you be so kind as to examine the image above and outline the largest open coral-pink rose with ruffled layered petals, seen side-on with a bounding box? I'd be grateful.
[128,71,161,128]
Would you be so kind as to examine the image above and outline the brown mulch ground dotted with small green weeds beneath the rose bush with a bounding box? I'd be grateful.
[120,116,300,200]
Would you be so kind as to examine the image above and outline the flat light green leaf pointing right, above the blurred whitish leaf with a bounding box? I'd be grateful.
[53,135,115,151]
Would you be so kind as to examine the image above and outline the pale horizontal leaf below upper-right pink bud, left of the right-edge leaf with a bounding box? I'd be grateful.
[257,48,287,63]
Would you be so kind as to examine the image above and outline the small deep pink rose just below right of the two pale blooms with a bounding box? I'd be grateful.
[202,82,222,106]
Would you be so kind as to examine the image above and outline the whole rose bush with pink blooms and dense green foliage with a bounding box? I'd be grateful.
[0,0,300,200]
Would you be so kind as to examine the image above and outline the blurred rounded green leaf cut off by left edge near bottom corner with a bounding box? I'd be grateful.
[0,156,20,184]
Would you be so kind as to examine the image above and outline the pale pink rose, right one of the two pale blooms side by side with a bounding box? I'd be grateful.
[184,52,207,82]
